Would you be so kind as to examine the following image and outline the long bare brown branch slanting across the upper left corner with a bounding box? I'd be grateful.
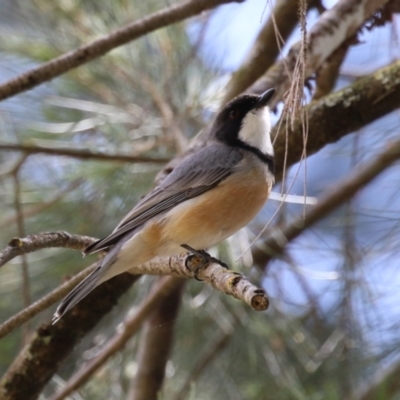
[0,0,240,100]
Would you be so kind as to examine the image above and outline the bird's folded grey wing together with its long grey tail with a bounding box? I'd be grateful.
[53,145,243,323]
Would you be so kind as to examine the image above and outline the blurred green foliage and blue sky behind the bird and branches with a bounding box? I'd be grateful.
[0,0,400,400]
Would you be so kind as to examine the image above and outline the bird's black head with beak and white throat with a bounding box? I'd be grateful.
[210,89,275,156]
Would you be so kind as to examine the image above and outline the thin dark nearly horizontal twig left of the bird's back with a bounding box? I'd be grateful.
[0,143,169,164]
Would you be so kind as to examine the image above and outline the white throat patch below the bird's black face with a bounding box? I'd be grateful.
[239,107,274,156]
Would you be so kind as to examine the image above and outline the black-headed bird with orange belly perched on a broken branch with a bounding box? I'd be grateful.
[53,89,275,323]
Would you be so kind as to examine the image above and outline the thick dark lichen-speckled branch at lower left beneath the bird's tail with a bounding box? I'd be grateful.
[0,274,139,400]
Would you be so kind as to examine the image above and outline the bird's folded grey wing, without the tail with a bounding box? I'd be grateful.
[84,144,243,254]
